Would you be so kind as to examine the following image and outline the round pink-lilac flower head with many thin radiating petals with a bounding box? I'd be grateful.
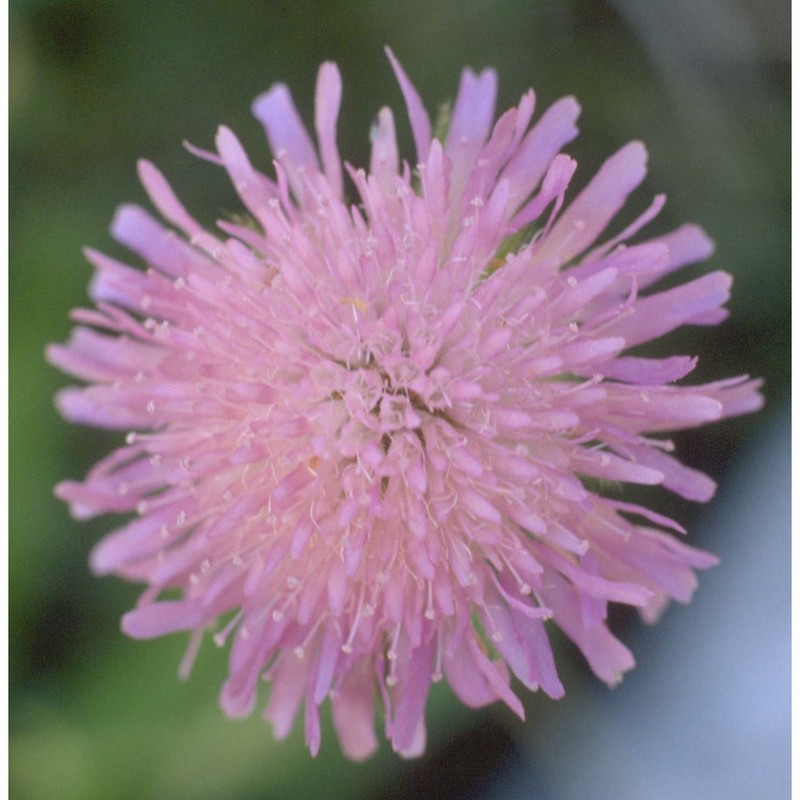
[48,53,761,759]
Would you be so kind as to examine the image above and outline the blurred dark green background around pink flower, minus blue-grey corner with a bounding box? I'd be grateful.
[9,0,790,800]
